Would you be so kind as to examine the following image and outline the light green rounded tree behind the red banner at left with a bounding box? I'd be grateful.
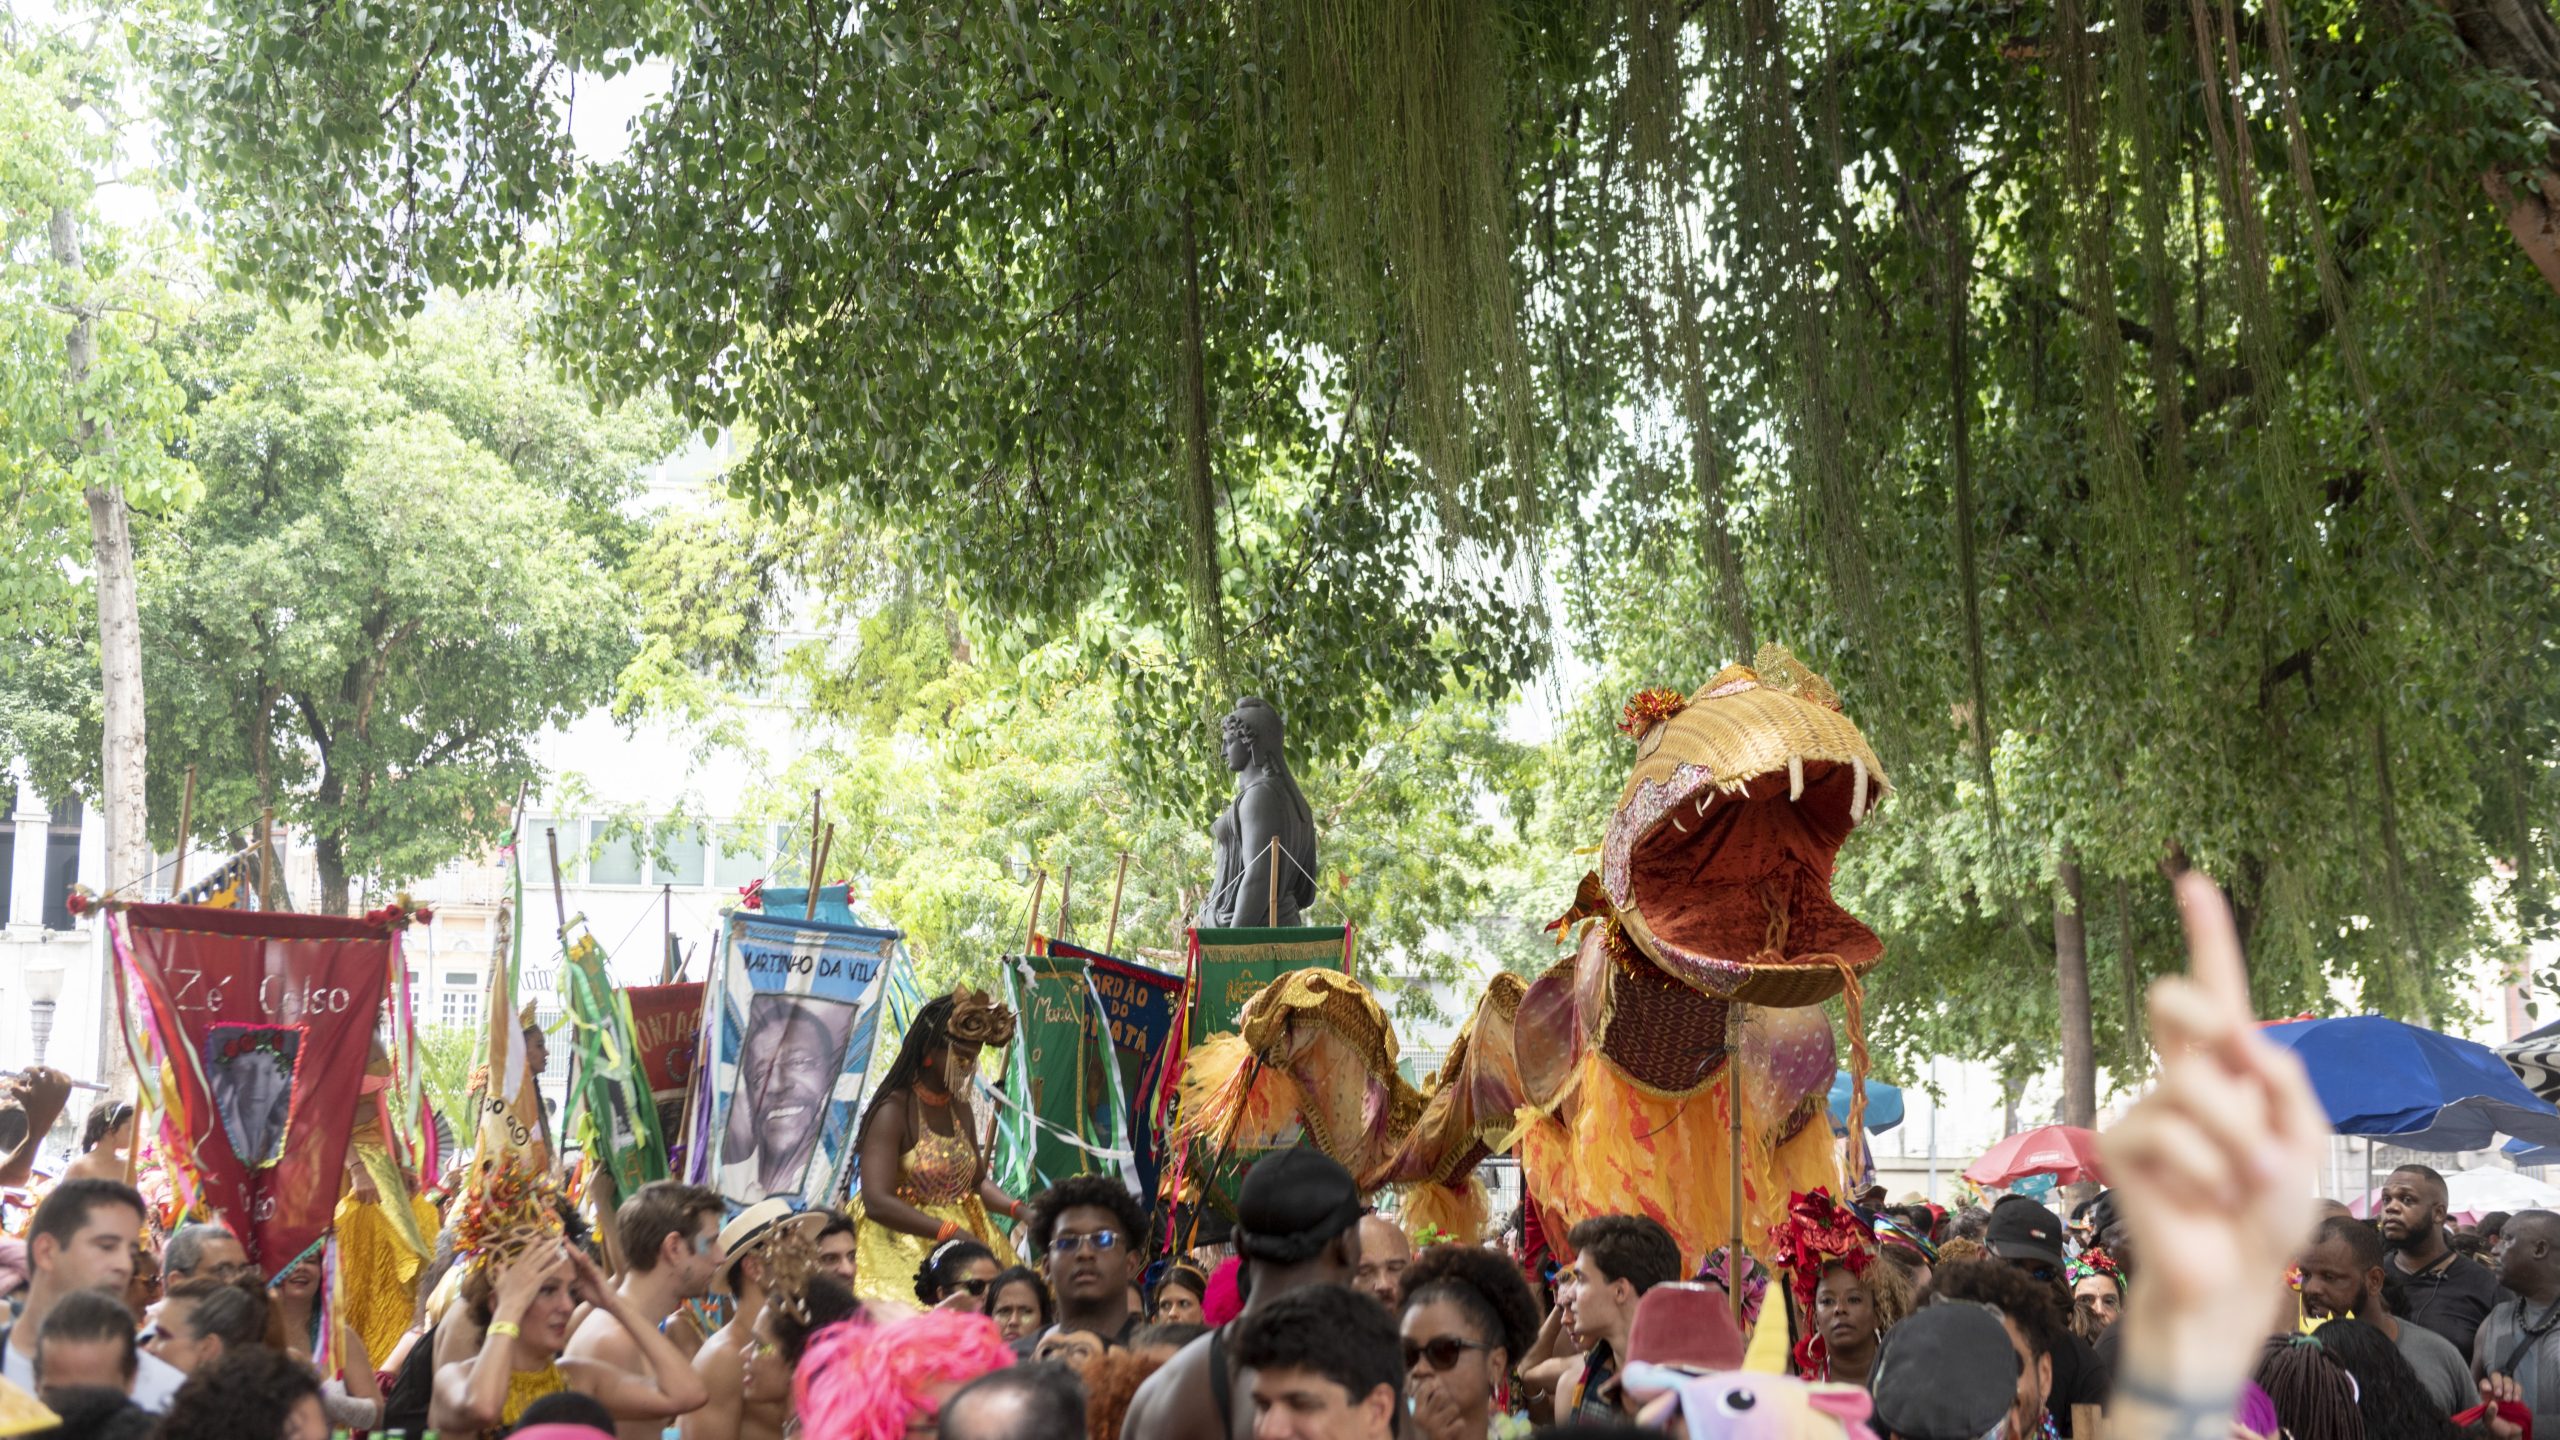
[141,302,673,912]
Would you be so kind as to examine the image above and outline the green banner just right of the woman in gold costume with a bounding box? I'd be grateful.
[996,956,1134,1194]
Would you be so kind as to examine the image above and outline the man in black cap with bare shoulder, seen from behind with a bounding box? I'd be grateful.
[1121,1145,1370,1440]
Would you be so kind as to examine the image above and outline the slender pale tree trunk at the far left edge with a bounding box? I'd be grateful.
[46,205,151,1092]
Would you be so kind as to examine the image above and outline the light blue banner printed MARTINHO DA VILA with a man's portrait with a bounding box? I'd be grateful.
[686,912,904,1207]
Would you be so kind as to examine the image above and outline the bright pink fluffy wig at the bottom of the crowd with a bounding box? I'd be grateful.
[791,1309,1014,1440]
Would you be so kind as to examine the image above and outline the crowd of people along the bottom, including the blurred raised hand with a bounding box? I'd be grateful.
[0,884,2529,1440]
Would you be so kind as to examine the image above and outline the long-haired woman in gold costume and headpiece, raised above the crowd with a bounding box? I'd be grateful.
[852,989,1027,1304]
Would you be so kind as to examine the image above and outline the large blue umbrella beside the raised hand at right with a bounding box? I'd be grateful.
[2263,1015,2560,1150]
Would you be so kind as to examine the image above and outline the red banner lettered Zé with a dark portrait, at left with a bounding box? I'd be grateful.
[115,904,399,1276]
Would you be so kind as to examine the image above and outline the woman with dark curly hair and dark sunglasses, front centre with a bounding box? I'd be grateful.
[1395,1245,1539,1440]
